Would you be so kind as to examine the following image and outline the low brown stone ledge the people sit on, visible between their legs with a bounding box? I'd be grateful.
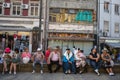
[0,63,120,73]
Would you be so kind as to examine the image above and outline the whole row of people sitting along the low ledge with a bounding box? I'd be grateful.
[0,46,115,76]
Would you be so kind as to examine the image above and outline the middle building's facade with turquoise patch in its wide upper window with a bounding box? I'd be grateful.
[48,0,96,55]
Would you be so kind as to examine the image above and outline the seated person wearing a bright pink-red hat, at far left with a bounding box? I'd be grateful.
[2,48,11,74]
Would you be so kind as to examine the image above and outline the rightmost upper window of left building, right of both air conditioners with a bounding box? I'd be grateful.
[29,1,39,16]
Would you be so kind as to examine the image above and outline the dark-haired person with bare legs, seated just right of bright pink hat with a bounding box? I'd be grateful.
[9,49,19,74]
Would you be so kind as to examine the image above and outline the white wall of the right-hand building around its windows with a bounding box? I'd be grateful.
[99,0,120,37]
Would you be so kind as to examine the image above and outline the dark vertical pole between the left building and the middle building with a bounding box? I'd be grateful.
[38,0,42,47]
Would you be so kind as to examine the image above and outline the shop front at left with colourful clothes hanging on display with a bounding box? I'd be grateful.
[0,27,30,52]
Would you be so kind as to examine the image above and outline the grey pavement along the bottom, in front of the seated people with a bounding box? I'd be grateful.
[0,72,120,80]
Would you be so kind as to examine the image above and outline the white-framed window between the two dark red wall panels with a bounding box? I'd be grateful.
[12,2,21,16]
